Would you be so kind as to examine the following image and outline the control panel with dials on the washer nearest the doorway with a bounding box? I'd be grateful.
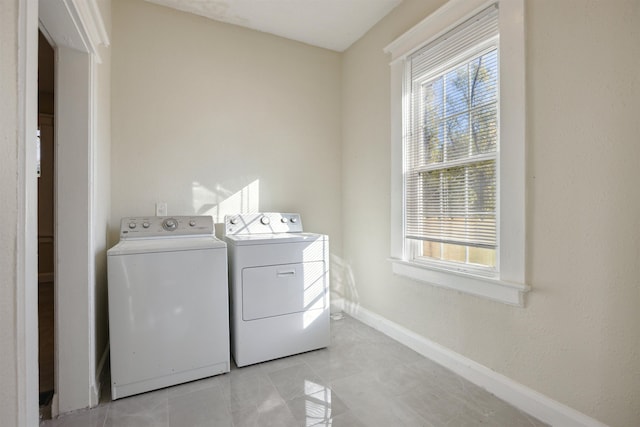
[120,216,213,239]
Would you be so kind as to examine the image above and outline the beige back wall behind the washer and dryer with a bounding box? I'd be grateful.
[111,0,341,253]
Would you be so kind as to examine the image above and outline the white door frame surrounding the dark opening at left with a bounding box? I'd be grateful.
[17,0,109,425]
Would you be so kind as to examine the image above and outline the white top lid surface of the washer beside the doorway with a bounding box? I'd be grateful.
[107,236,227,256]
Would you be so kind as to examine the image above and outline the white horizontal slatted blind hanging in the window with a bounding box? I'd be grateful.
[404,5,499,249]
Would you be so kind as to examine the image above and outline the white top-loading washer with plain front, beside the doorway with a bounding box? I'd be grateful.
[107,216,231,399]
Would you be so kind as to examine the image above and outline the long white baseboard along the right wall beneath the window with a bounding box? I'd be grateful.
[332,300,607,427]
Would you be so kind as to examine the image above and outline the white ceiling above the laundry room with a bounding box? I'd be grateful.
[146,0,402,52]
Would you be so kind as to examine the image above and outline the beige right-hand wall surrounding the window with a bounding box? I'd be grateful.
[341,0,640,426]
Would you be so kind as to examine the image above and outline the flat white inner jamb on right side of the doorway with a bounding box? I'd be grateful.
[55,46,95,413]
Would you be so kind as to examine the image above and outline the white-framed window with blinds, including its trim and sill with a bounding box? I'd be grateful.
[386,0,528,305]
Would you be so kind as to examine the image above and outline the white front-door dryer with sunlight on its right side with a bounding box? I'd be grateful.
[225,213,330,366]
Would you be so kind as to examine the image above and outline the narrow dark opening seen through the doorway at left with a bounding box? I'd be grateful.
[37,32,55,419]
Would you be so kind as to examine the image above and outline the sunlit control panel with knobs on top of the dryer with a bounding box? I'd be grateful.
[224,212,302,235]
